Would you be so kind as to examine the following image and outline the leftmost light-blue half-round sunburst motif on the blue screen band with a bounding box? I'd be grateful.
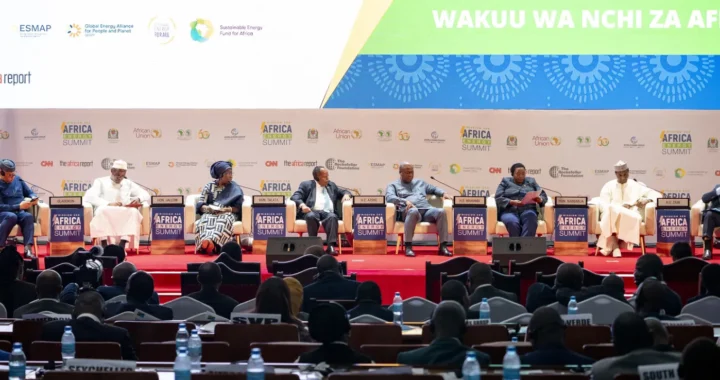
[368,55,450,103]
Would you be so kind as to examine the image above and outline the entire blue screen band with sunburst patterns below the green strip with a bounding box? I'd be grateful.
[325,55,720,110]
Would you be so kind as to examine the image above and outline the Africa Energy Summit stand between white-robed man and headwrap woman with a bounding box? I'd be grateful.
[150,195,185,255]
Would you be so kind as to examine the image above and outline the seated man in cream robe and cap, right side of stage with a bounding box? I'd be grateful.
[597,161,653,257]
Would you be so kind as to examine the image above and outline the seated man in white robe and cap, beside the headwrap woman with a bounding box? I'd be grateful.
[84,160,150,248]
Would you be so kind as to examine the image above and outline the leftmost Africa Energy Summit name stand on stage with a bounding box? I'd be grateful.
[48,197,85,256]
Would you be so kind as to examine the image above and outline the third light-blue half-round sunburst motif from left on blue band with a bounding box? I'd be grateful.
[545,55,625,103]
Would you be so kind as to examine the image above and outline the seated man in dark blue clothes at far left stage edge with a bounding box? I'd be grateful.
[0,159,38,258]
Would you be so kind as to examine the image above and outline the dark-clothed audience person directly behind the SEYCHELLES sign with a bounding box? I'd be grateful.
[40,290,137,360]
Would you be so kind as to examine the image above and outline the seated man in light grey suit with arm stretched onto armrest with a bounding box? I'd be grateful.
[385,162,452,257]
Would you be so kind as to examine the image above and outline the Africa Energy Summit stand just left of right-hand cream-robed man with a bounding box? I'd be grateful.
[553,196,589,256]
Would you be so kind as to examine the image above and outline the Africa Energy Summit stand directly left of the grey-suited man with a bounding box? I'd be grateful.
[352,195,387,255]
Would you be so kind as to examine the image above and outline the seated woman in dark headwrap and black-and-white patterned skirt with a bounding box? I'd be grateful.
[195,161,243,254]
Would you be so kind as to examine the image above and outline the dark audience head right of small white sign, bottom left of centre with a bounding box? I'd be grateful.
[308,302,350,344]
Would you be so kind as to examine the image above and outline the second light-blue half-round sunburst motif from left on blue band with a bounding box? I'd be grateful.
[455,55,537,103]
